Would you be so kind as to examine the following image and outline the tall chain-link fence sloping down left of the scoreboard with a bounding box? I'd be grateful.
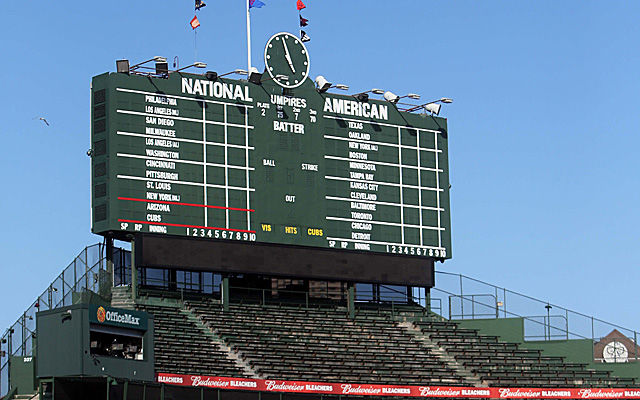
[0,243,111,396]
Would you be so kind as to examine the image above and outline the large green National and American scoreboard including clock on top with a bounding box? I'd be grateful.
[91,33,451,259]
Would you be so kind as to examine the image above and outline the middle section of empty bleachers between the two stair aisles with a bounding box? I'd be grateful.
[187,301,464,385]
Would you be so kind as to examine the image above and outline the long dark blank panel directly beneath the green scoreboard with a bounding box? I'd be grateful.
[135,234,435,288]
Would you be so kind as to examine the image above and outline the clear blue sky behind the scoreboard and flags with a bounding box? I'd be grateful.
[0,0,640,330]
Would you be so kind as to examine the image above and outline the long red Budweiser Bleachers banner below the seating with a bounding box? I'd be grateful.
[156,373,640,399]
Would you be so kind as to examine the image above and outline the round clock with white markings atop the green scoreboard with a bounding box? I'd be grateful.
[264,32,309,88]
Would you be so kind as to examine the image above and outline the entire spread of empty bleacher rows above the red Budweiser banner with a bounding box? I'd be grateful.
[140,299,637,388]
